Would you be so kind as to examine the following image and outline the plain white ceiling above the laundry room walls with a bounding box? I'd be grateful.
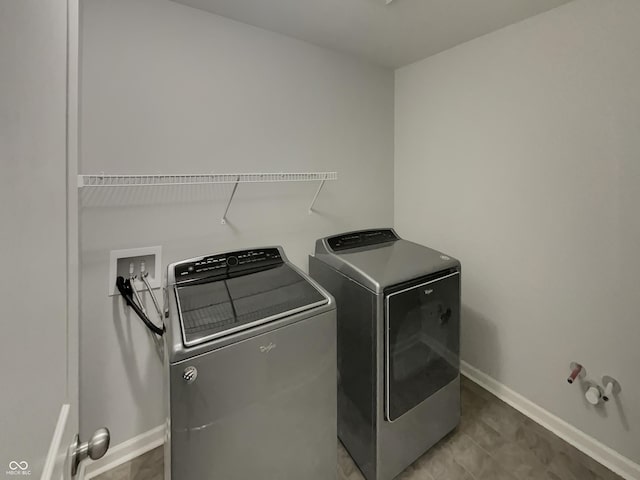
[174,0,570,67]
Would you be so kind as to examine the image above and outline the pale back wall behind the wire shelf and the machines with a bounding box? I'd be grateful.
[80,0,394,443]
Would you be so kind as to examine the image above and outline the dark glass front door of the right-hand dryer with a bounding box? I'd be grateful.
[385,272,460,422]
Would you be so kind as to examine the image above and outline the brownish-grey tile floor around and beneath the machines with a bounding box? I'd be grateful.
[95,377,621,480]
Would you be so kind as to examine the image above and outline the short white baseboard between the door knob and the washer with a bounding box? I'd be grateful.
[80,425,165,480]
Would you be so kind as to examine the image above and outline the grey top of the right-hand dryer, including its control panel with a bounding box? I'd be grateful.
[315,228,460,293]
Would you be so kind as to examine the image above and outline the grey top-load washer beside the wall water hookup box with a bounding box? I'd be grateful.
[165,247,337,480]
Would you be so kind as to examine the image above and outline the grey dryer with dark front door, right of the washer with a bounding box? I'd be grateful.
[309,229,460,480]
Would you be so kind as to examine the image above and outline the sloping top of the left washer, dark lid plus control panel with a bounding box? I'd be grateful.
[173,248,329,347]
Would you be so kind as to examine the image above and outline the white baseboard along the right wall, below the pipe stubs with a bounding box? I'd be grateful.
[461,362,640,480]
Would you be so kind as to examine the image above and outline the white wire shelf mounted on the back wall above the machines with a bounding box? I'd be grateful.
[78,172,338,188]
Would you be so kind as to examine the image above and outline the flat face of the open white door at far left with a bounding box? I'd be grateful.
[0,0,69,478]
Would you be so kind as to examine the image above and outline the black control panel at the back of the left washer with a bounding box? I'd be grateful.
[174,248,284,282]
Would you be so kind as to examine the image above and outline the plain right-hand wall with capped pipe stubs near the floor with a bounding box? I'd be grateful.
[395,0,640,462]
